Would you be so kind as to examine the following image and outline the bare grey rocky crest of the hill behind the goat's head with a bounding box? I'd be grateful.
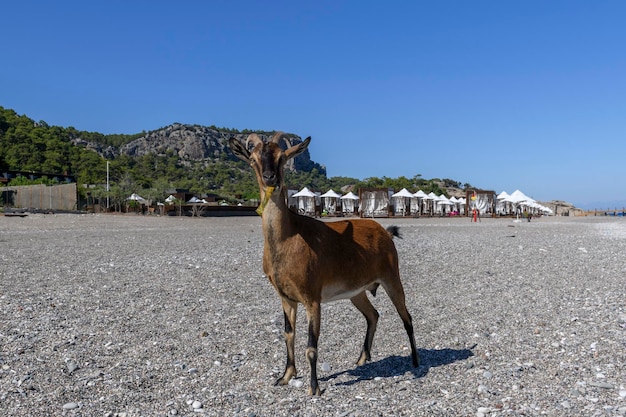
[72,123,326,173]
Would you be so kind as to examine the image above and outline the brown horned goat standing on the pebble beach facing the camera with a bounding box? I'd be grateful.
[230,132,419,395]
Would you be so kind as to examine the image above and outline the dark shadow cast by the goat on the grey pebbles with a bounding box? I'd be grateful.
[320,346,474,385]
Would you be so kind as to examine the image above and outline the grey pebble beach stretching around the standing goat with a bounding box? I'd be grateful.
[0,214,626,417]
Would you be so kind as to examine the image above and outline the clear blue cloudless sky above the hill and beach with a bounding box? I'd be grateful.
[0,0,626,207]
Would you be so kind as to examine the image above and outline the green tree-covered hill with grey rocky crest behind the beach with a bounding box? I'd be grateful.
[0,107,458,198]
